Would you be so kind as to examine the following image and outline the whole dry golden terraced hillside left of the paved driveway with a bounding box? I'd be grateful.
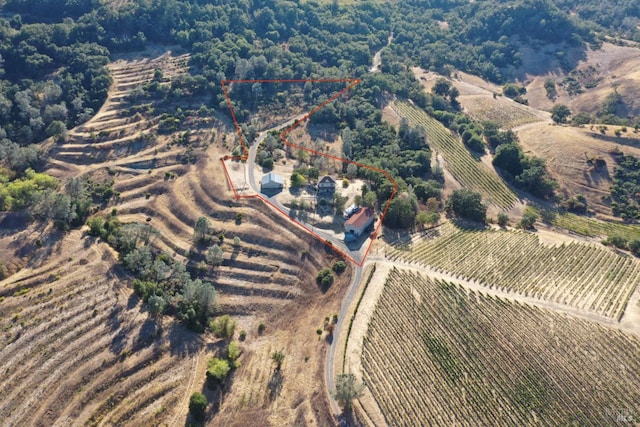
[0,47,350,426]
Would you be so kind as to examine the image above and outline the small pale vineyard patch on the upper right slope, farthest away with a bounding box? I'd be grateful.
[460,95,544,129]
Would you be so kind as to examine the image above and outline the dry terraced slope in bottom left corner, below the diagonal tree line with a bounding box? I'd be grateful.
[0,231,198,425]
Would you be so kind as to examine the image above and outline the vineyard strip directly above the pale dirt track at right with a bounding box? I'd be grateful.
[389,224,640,319]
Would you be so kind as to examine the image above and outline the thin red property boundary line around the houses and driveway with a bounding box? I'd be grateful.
[220,79,398,267]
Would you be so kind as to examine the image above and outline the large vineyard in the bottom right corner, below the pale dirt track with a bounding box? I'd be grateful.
[362,268,640,426]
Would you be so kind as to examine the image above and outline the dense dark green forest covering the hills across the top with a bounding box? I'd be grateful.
[0,0,639,229]
